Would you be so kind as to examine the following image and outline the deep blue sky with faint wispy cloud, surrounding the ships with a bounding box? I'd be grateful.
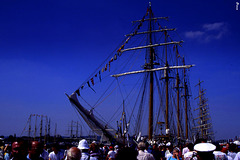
[0,0,240,139]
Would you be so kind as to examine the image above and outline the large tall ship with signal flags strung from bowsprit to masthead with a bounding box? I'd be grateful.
[67,3,206,143]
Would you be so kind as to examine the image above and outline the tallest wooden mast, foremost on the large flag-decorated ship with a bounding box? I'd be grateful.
[148,2,154,139]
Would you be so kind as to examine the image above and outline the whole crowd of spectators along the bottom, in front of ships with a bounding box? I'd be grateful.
[0,139,240,160]
